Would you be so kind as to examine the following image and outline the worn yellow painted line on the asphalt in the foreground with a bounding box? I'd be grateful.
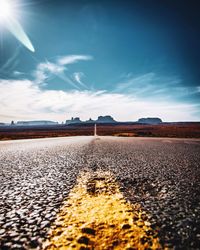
[43,172,161,250]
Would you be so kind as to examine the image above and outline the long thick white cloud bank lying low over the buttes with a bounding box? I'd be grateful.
[0,77,199,121]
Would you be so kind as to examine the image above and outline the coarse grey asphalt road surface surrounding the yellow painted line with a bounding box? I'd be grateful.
[0,137,200,249]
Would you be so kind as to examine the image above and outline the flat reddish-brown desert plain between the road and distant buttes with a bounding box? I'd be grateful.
[0,122,200,140]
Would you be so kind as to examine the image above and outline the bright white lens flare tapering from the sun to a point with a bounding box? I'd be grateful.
[0,0,35,52]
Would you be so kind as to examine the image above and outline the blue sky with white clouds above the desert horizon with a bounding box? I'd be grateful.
[0,0,200,122]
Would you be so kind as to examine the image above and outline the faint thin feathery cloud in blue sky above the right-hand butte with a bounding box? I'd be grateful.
[113,72,198,100]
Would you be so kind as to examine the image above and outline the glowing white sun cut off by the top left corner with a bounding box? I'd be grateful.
[0,0,14,21]
